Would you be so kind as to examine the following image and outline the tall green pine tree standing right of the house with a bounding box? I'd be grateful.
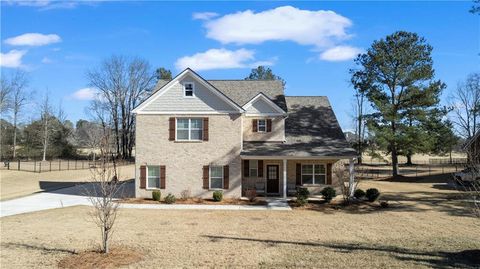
[352,31,445,176]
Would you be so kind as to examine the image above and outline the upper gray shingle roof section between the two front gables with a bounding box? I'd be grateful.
[208,80,287,111]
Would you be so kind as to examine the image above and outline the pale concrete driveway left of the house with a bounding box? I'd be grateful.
[0,181,134,217]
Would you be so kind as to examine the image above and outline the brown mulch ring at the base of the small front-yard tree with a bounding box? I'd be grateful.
[58,247,143,269]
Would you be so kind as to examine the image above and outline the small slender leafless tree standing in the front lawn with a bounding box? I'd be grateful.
[86,133,122,253]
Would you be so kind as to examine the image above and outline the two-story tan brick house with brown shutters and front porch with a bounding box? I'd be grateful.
[134,69,356,197]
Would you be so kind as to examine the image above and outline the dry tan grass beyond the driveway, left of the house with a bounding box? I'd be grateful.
[0,165,135,200]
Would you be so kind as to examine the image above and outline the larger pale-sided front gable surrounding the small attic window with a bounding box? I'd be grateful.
[133,68,244,114]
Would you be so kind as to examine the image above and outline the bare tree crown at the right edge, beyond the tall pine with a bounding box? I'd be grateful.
[450,73,480,139]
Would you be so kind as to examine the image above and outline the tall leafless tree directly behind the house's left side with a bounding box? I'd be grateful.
[87,56,155,158]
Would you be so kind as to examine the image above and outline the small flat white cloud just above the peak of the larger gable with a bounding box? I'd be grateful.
[175,48,273,70]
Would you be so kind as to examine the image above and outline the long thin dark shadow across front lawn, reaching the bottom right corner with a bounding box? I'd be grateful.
[203,235,480,268]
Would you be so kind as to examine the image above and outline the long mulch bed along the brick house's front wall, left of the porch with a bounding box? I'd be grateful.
[120,198,267,205]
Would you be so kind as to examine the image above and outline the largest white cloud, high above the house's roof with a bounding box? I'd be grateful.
[204,6,352,48]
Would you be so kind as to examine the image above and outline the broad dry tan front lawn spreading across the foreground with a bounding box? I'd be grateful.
[0,175,480,268]
